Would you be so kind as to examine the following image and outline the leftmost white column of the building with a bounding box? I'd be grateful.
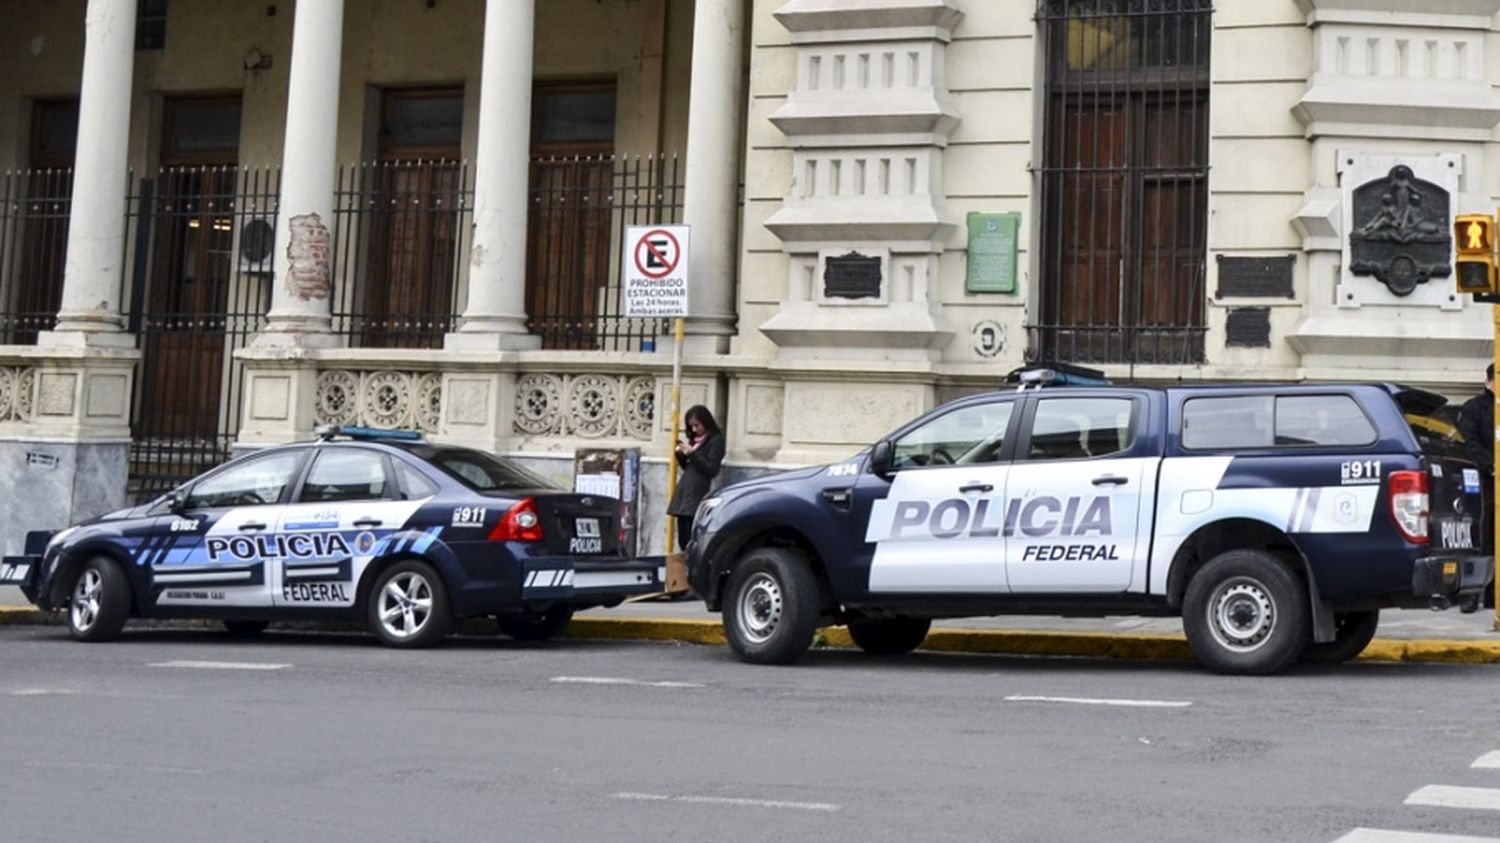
[44,0,135,345]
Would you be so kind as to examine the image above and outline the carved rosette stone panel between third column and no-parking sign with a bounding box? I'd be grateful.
[515,374,656,441]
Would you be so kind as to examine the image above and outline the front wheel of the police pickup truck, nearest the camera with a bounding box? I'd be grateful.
[723,548,819,665]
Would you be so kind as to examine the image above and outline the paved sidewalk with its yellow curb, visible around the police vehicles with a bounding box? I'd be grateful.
[11,587,1500,665]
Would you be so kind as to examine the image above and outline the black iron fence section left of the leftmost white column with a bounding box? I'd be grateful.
[0,170,74,345]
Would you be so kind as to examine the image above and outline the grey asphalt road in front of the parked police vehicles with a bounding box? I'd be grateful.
[0,627,1500,842]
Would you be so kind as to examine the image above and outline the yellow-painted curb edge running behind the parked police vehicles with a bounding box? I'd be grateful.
[0,606,1500,665]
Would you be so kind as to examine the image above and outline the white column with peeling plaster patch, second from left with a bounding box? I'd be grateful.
[257,0,344,347]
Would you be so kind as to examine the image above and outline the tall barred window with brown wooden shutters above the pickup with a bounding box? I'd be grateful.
[1029,0,1214,363]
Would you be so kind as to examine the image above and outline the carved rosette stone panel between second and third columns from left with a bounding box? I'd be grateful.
[314,369,443,434]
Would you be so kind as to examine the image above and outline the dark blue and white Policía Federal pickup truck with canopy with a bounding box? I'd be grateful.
[689,378,1494,674]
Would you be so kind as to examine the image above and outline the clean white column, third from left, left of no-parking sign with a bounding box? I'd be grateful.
[446,0,540,348]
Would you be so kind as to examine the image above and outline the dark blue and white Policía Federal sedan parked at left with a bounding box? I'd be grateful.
[0,428,665,647]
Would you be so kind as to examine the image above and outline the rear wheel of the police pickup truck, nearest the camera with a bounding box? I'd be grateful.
[1182,551,1313,675]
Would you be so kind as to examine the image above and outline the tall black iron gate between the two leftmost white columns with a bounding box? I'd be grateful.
[125,167,281,500]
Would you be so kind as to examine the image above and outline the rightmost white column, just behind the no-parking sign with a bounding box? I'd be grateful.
[683,0,746,351]
